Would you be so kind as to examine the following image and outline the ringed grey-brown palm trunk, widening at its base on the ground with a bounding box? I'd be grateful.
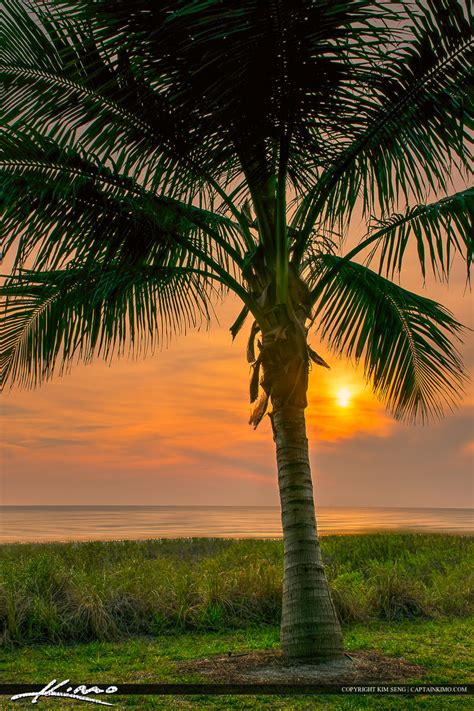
[272,406,343,661]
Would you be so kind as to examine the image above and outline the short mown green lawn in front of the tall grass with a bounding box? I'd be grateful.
[0,618,473,711]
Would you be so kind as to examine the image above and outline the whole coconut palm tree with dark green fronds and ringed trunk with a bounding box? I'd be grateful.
[0,0,473,660]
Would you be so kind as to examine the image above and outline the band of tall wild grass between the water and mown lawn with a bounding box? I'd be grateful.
[0,533,473,644]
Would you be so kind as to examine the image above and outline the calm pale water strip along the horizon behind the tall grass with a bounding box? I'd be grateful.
[0,506,474,543]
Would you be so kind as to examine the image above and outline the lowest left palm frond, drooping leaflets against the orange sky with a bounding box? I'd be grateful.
[0,264,215,387]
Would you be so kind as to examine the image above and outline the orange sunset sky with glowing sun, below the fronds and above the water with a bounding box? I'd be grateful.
[0,246,474,508]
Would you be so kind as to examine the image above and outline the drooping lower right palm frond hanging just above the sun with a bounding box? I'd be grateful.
[312,255,465,421]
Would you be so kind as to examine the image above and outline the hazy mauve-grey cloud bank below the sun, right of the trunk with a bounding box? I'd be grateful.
[312,411,474,508]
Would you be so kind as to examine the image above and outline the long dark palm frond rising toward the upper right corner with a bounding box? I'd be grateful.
[293,0,473,259]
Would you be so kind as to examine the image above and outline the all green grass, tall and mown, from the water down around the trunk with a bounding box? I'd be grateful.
[0,533,474,711]
